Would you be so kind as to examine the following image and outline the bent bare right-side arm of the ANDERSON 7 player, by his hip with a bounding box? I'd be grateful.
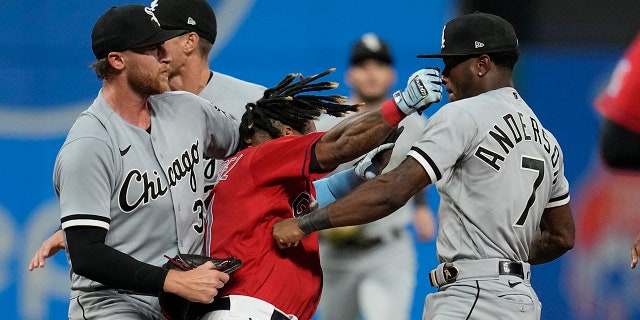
[528,203,576,264]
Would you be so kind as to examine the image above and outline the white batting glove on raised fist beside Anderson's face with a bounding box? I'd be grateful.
[393,67,442,115]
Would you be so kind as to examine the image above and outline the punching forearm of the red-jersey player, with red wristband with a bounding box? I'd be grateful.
[315,100,404,169]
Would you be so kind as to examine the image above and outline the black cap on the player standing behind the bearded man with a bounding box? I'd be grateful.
[149,0,218,43]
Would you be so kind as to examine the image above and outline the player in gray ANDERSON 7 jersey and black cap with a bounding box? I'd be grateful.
[273,12,575,319]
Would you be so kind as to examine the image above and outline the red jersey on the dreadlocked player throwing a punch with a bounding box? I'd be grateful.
[205,133,326,320]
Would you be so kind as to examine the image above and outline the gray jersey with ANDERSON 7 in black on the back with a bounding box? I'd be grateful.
[408,88,569,262]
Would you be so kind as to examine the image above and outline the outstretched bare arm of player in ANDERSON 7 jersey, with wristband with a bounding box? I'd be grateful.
[273,157,431,246]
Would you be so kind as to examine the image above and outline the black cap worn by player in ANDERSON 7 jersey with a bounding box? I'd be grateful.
[418,12,518,58]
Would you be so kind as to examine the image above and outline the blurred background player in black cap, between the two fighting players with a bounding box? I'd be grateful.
[316,33,435,320]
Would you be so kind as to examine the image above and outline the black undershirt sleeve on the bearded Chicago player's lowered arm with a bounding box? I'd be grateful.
[64,227,168,294]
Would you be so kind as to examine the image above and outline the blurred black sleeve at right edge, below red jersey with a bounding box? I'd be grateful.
[599,118,640,170]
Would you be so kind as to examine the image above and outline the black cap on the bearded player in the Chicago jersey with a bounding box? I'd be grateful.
[91,5,186,59]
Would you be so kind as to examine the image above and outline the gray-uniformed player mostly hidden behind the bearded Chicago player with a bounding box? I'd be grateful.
[29,0,265,270]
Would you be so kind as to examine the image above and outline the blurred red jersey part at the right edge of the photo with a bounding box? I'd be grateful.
[596,34,640,133]
